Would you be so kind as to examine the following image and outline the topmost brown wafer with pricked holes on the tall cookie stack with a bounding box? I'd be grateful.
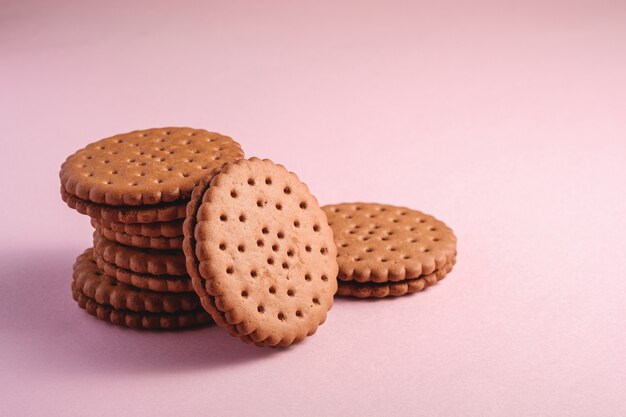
[59,127,243,206]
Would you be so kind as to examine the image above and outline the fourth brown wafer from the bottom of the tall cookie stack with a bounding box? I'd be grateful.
[93,232,187,275]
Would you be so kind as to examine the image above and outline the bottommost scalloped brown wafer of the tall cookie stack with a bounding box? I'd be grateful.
[72,282,213,330]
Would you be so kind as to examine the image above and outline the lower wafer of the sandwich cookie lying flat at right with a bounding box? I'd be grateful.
[337,258,456,298]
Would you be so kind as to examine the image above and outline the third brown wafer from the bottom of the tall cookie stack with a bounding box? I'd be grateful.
[94,255,193,292]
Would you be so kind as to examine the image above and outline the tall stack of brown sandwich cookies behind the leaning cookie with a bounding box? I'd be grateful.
[60,128,243,329]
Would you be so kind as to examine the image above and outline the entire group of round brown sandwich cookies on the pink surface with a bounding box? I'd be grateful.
[61,128,456,346]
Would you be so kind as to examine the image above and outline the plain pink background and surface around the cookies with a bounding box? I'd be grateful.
[0,0,626,417]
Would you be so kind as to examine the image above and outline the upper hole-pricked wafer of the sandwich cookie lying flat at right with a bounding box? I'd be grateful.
[323,203,456,282]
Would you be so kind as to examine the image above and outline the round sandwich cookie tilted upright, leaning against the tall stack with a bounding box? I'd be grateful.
[183,158,338,346]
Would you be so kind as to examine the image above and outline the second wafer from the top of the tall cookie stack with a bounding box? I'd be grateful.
[61,187,187,224]
